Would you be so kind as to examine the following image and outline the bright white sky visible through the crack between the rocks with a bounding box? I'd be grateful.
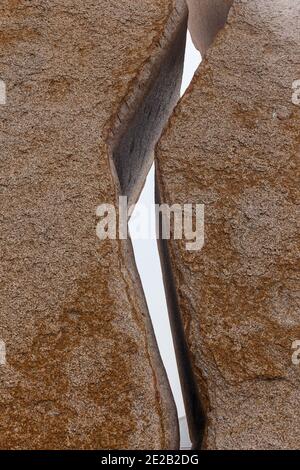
[129,33,201,449]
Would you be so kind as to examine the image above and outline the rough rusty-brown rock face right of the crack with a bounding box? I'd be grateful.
[157,0,300,449]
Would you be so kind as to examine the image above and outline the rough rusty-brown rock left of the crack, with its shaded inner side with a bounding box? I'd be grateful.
[0,0,187,449]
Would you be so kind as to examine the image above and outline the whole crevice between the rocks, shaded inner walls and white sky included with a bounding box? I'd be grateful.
[109,0,233,449]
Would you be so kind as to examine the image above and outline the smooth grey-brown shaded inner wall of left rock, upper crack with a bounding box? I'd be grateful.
[112,8,187,204]
